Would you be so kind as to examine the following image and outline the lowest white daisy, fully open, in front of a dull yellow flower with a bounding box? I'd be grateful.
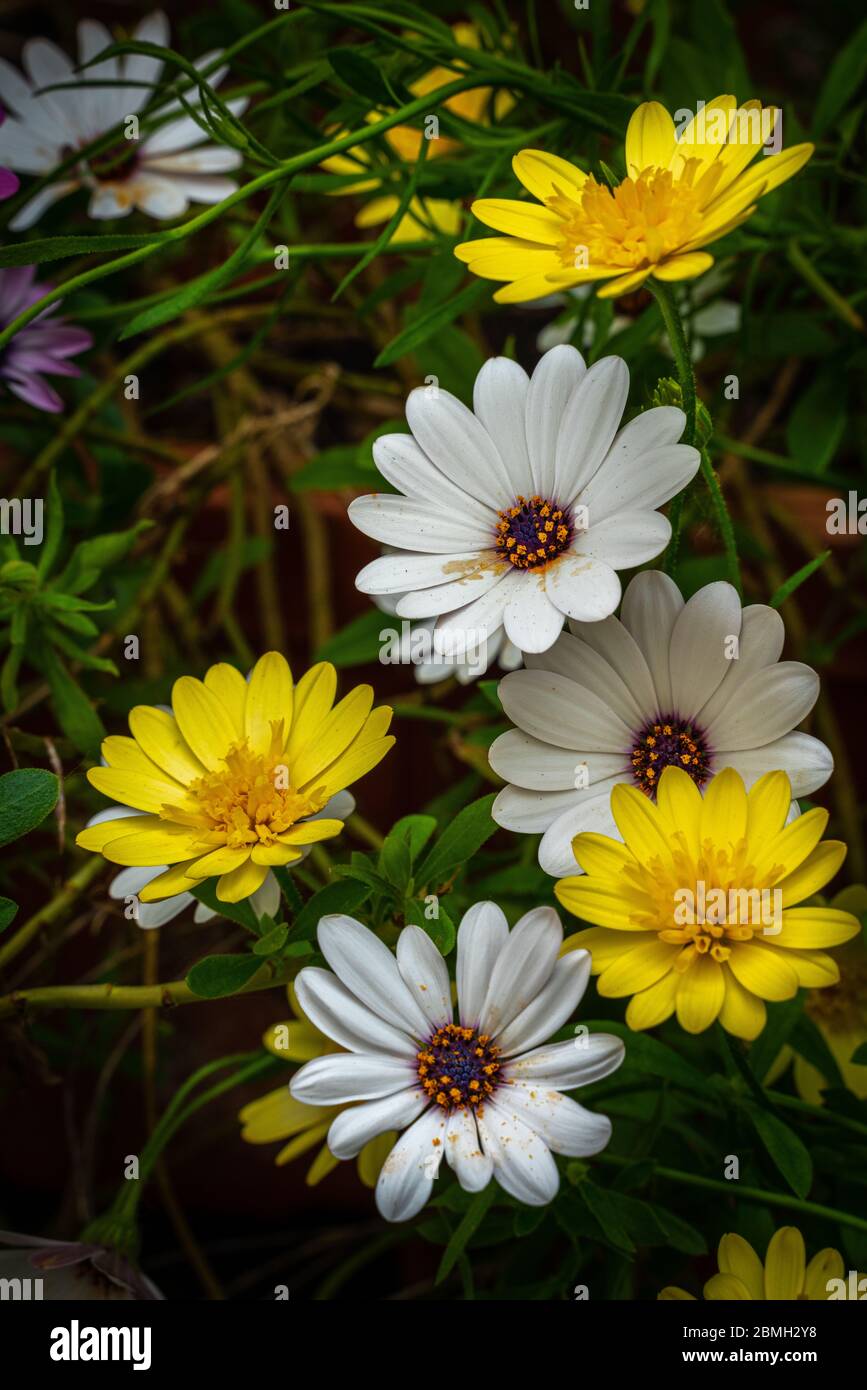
[289,902,624,1220]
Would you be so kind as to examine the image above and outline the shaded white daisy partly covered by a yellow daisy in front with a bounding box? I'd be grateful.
[489,570,834,878]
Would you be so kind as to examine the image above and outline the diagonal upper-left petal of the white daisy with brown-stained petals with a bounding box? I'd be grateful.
[406,386,514,512]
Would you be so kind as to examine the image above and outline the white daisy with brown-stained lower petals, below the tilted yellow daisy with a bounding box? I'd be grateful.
[349,346,699,652]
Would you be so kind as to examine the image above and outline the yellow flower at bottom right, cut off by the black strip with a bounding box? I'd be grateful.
[659,1226,845,1302]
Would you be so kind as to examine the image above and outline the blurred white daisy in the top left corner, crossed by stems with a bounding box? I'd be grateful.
[0,11,247,231]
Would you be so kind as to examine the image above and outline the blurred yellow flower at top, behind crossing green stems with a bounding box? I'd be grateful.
[322,24,514,246]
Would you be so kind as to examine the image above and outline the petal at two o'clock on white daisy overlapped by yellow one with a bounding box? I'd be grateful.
[705,662,818,753]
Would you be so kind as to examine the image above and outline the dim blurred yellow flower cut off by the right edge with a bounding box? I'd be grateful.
[767,883,867,1105]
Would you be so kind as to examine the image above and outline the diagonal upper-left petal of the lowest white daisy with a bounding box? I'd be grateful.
[317,915,428,1038]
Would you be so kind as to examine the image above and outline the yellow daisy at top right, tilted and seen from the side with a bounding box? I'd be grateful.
[454,96,813,304]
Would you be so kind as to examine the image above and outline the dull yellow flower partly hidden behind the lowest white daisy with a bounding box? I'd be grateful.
[238,986,397,1187]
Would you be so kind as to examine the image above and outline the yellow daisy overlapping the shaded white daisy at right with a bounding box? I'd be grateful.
[554,767,860,1038]
